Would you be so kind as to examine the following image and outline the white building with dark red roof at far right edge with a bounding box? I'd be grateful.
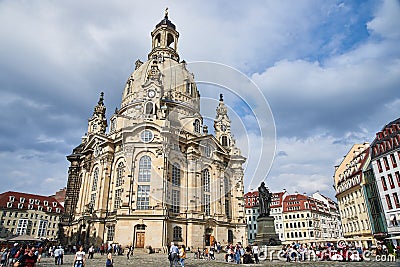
[371,118,400,246]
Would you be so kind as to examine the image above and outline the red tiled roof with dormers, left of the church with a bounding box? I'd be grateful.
[0,191,64,213]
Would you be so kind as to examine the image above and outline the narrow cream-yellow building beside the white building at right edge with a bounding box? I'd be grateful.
[334,143,376,248]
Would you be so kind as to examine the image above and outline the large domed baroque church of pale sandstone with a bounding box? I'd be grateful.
[63,13,247,249]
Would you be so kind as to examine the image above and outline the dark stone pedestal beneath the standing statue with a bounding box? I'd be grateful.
[255,216,281,246]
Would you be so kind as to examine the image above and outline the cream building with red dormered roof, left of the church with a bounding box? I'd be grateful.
[0,191,64,240]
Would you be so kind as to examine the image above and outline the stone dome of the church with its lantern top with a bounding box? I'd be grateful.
[119,11,201,122]
